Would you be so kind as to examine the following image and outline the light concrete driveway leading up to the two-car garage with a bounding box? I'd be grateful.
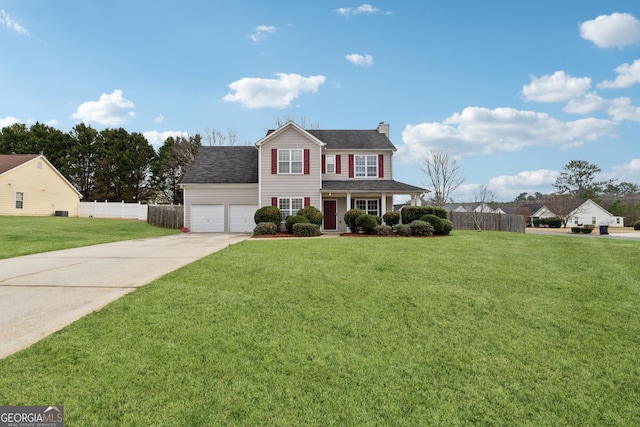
[0,233,250,358]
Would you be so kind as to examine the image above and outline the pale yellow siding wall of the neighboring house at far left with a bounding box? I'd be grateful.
[0,158,80,217]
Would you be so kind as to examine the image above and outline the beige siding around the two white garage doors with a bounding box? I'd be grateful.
[184,184,258,231]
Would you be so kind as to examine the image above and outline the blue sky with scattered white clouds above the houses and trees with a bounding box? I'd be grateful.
[0,0,640,201]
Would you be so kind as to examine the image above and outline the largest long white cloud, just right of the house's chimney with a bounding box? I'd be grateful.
[398,107,616,162]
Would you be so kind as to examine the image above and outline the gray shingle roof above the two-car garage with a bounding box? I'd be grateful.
[182,146,258,184]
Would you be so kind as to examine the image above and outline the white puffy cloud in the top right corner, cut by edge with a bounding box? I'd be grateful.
[580,13,640,48]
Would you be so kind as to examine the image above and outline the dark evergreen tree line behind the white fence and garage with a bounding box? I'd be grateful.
[0,123,237,204]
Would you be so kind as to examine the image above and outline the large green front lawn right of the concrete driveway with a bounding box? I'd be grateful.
[0,232,640,426]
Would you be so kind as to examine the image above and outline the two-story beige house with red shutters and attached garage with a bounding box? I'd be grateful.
[181,121,426,232]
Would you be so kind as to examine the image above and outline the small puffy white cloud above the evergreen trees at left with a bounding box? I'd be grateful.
[71,89,136,126]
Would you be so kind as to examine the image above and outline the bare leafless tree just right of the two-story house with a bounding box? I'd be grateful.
[422,149,465,206]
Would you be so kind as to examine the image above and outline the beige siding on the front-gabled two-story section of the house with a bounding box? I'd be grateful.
[260,129,322,208]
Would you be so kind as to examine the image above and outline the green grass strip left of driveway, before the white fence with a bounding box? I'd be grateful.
[0,216,178,259]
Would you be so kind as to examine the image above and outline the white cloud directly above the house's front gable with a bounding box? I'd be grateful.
[223,73,326,108]
